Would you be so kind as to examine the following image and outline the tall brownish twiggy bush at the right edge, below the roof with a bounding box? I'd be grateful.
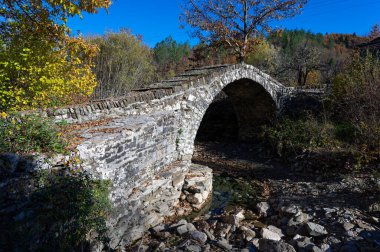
[330,52,380,151]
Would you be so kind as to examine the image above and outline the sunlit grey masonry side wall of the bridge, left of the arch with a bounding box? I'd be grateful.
[77,111,184,246]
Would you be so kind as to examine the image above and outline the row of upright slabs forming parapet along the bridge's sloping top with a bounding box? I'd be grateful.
[43,64,294,123]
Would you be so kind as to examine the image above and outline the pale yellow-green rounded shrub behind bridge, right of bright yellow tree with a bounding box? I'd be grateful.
[87,30,156,99]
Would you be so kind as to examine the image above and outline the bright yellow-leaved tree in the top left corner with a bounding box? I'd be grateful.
[0,0,111,111]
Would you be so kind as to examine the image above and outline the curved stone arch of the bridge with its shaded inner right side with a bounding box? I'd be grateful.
[177,64,286,160]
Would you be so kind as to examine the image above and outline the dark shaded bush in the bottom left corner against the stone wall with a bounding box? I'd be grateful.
[1,171,110,251]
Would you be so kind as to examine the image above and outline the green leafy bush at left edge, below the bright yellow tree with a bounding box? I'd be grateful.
[0,114,65,154]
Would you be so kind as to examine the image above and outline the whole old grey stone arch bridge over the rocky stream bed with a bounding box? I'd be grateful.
[46,64,324,246]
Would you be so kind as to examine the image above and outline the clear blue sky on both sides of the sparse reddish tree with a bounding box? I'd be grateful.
[68,0,380,47]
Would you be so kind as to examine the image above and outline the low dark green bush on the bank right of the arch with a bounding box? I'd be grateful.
[262,116,379,171]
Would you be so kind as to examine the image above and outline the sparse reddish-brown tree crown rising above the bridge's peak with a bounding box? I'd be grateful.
[182,0,307,61]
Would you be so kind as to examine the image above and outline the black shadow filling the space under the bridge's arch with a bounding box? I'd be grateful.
[195,78,277,142]
